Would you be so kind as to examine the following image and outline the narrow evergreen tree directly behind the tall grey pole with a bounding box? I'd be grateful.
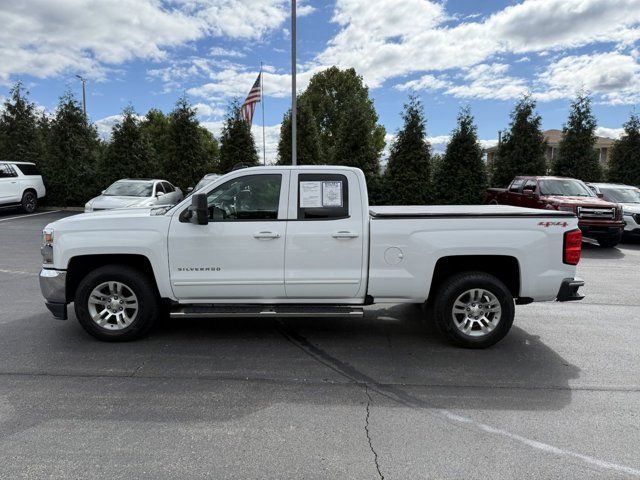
[278,97,322,165]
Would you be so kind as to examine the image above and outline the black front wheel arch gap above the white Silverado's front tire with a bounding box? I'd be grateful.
[66,254,160,302]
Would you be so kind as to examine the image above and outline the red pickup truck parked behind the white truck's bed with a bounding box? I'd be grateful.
[487,176,624,247]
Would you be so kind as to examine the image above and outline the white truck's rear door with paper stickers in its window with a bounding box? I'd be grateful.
[285,171,368,299]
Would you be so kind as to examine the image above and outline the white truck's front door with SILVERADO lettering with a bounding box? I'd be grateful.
[168,172,289,301]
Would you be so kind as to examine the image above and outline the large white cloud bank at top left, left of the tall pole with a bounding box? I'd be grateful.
[0,0,294,83]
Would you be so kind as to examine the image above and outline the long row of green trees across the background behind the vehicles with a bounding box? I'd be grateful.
[0,67,640,206]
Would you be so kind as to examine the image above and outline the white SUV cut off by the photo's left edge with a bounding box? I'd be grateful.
[0,162,47,213]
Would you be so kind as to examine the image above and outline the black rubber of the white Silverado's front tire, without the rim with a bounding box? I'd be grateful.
[74,265,160,342]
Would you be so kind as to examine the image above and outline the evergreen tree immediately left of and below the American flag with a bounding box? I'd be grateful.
[220,101,259,173]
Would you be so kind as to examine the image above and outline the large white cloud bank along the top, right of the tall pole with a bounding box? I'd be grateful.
[316,0,640,94]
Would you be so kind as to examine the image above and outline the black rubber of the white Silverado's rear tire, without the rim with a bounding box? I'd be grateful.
[432,272,515,348]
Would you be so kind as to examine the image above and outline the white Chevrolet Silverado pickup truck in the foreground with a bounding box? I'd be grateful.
[40,166,583,348]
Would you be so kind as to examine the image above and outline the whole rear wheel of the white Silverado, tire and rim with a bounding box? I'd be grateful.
[433,272,515,348]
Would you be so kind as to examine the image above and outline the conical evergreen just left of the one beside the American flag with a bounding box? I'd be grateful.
[161,96,216,190]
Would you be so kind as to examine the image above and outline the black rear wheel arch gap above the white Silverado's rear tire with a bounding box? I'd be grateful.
[428,255,521,299]
